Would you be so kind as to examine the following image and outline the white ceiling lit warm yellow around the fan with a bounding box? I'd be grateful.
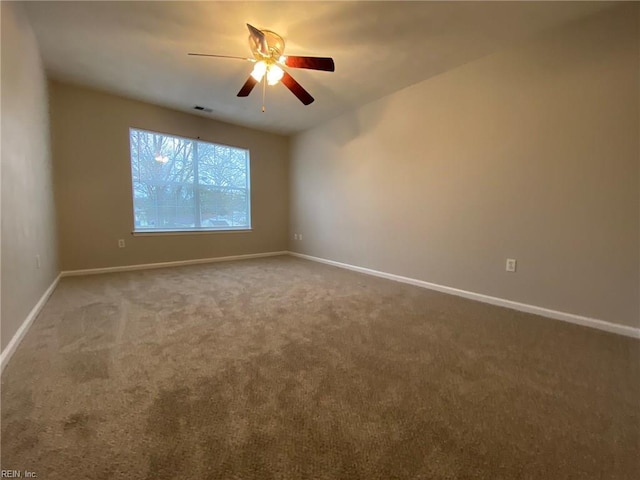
[25,1,613,134]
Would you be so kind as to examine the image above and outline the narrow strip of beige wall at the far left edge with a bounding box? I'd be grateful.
[0,2,58,350]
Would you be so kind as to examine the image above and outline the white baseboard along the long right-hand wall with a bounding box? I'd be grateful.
[289,252,640,338]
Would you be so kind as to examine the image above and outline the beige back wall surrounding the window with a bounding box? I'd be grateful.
[50,82,289,270]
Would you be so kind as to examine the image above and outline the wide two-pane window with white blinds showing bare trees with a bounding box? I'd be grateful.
[129,128,251,232]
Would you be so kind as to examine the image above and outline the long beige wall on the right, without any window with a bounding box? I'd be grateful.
[290,4,640,326]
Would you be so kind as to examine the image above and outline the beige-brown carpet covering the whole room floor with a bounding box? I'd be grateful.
[1,257,640,480]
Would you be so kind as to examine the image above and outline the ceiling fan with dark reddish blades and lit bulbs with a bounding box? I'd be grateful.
[189,23,335,112]
